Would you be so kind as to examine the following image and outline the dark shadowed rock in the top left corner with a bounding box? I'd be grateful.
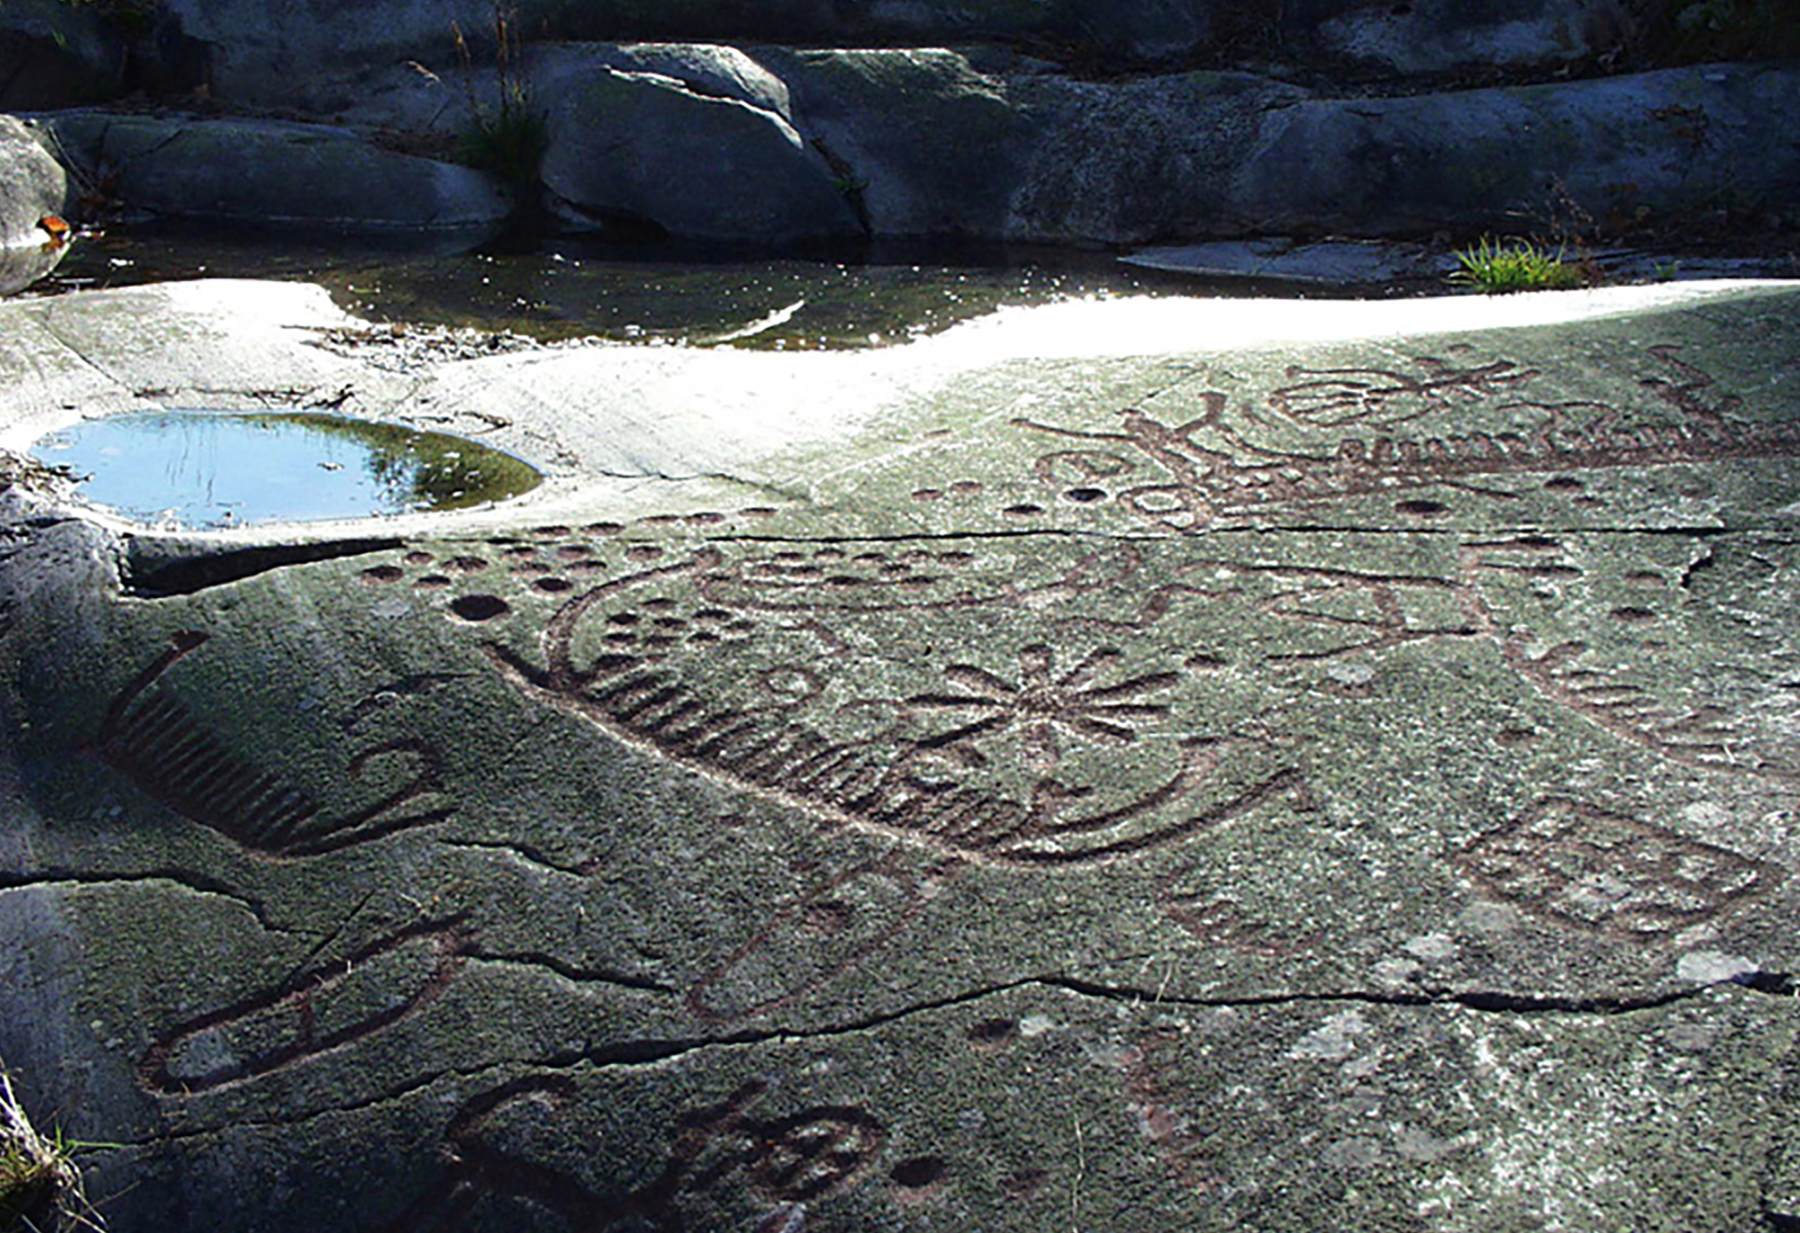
[0,0,126,112]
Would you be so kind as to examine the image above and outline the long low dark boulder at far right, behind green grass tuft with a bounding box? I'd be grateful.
[1224,65,1800,236]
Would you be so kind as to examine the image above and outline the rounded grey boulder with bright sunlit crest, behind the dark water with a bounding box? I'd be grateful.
[544,63,862,245]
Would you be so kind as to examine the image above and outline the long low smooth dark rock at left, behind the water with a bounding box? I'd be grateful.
[43,112,513,241]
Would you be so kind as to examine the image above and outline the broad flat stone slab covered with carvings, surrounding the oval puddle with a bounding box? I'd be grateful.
[0,284,1800,1233]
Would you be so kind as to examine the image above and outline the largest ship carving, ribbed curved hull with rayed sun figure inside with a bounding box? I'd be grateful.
[428,545,1305,868]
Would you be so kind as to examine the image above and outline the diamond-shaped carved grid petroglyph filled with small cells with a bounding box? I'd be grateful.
[1456,797,1786,941]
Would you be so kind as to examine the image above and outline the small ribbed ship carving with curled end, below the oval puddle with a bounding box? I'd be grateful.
[97,630,452,857]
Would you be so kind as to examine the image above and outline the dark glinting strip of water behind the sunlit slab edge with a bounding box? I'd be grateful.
[38,229,1271,349]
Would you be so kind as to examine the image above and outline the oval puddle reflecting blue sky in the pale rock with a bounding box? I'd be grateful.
[31,410,544,529]
